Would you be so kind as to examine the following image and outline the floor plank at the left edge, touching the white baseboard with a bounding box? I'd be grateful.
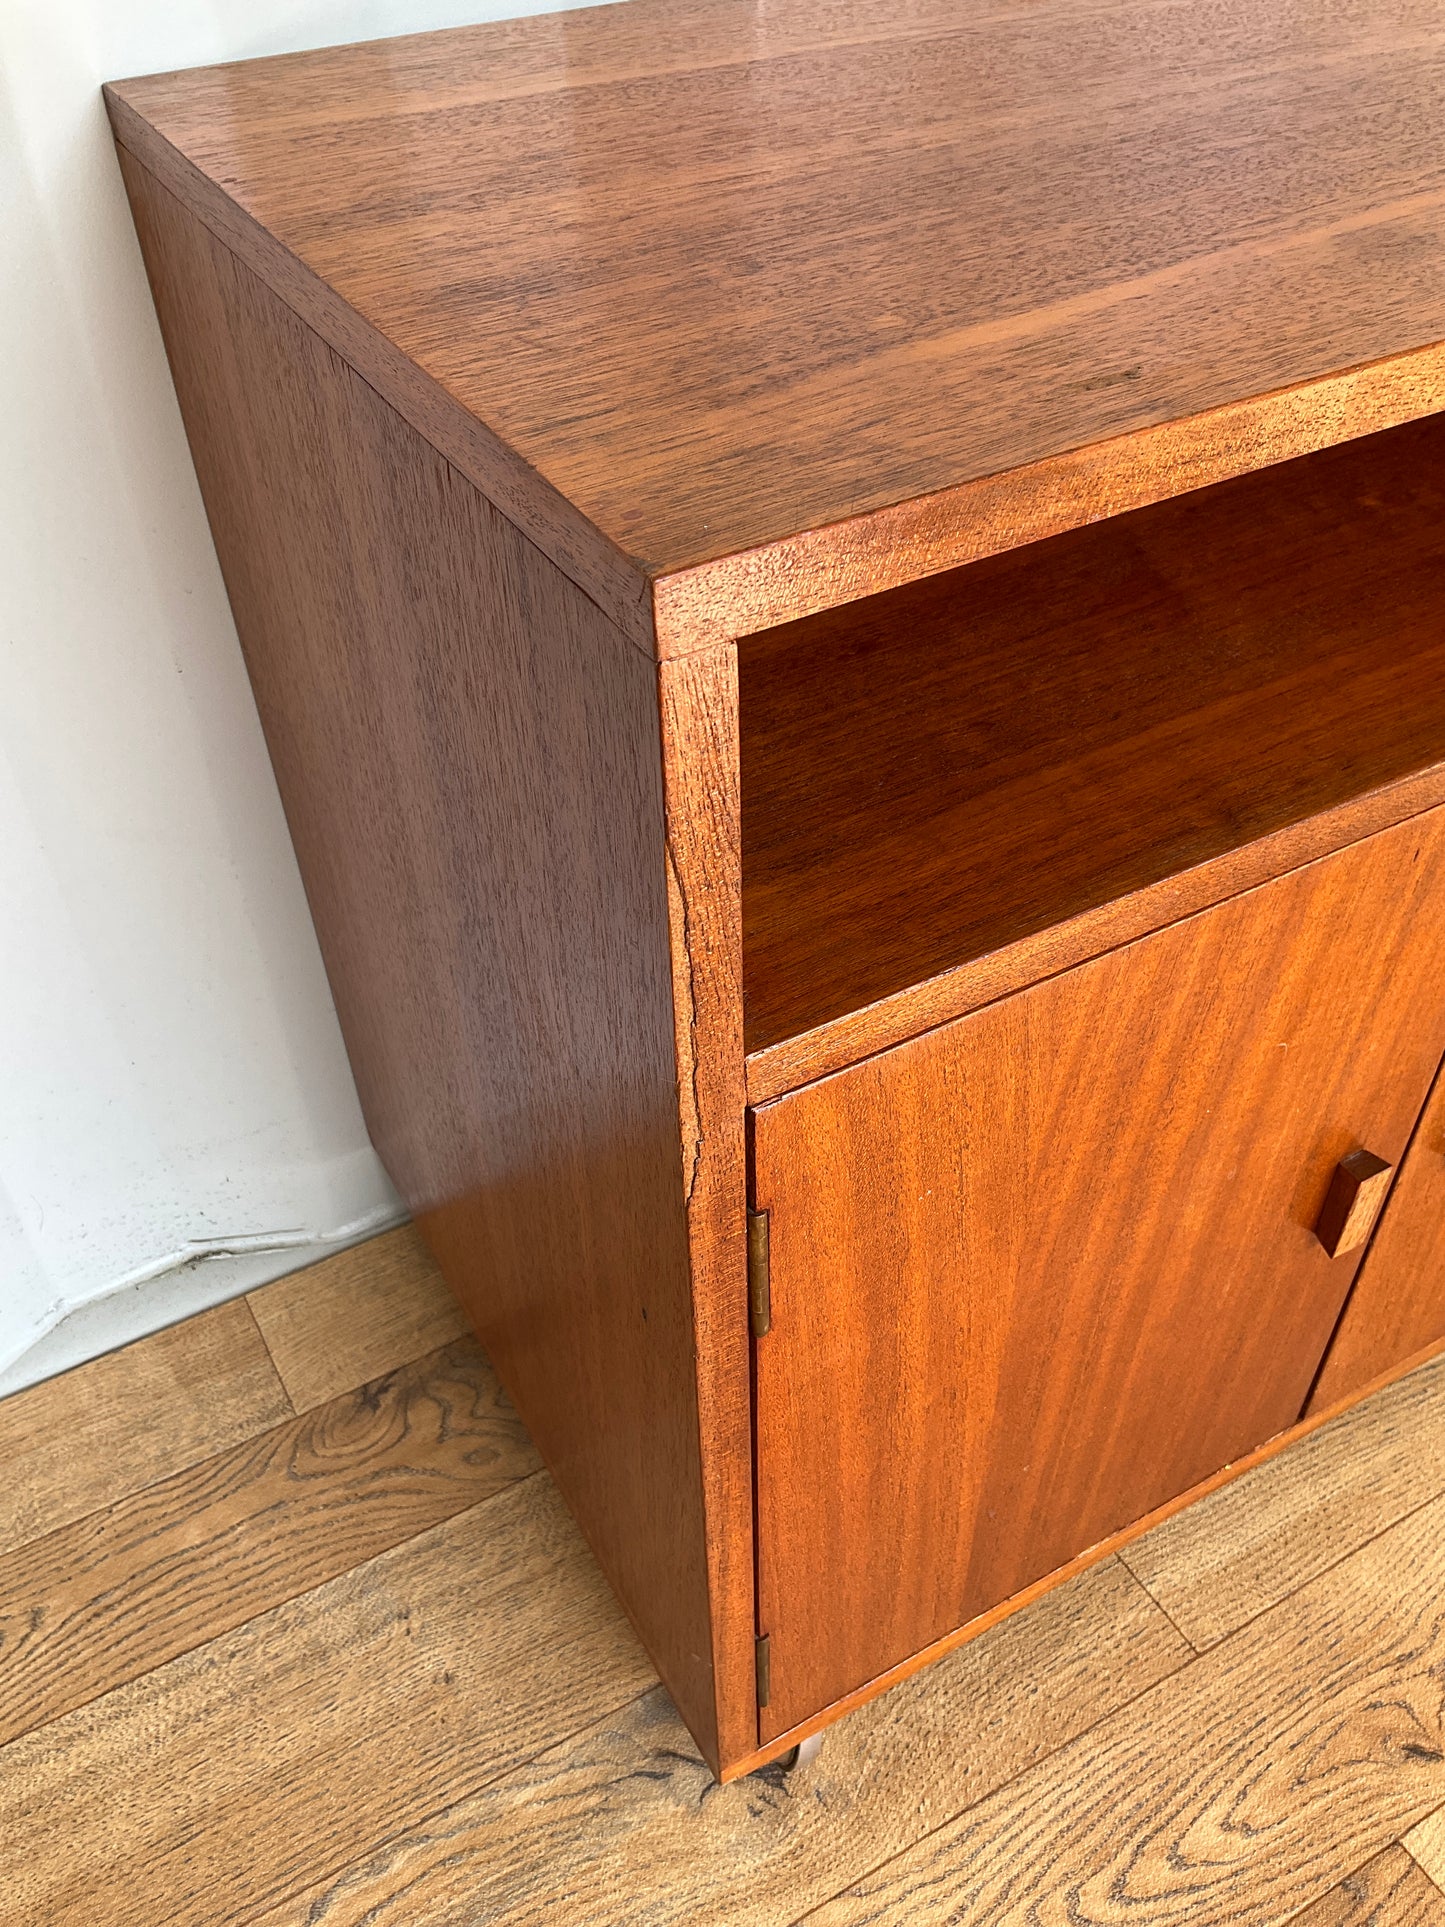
[0,1299,291,1551]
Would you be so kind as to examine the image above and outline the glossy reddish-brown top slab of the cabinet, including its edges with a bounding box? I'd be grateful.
[110,0,1445,655]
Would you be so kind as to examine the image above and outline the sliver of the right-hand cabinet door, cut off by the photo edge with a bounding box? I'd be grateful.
[1310,1077,1445,1409]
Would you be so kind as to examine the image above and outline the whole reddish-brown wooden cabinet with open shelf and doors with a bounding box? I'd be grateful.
[108,0,1445,1777]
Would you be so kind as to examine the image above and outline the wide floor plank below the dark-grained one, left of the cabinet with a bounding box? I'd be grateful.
[0,1472,655,1927]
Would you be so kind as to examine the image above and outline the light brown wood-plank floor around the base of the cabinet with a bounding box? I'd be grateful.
[0,1231,1445,1927]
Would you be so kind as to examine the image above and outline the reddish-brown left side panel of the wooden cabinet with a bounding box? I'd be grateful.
[121,156,748,1763]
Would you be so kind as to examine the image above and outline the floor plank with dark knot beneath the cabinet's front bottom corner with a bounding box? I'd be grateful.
[248,1561,1193,1927]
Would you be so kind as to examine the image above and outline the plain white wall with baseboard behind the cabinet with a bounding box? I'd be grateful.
[0,0,581,1391]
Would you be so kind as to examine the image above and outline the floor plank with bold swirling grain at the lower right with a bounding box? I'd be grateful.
[809,1499,1445,1927]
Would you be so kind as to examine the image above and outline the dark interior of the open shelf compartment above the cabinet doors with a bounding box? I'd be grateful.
[740,418,1445,1052]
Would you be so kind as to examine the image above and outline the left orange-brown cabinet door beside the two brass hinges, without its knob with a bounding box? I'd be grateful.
[753,811,1445,1738]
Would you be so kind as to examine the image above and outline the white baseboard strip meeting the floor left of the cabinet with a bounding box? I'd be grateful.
[0,1204,407,1397]
